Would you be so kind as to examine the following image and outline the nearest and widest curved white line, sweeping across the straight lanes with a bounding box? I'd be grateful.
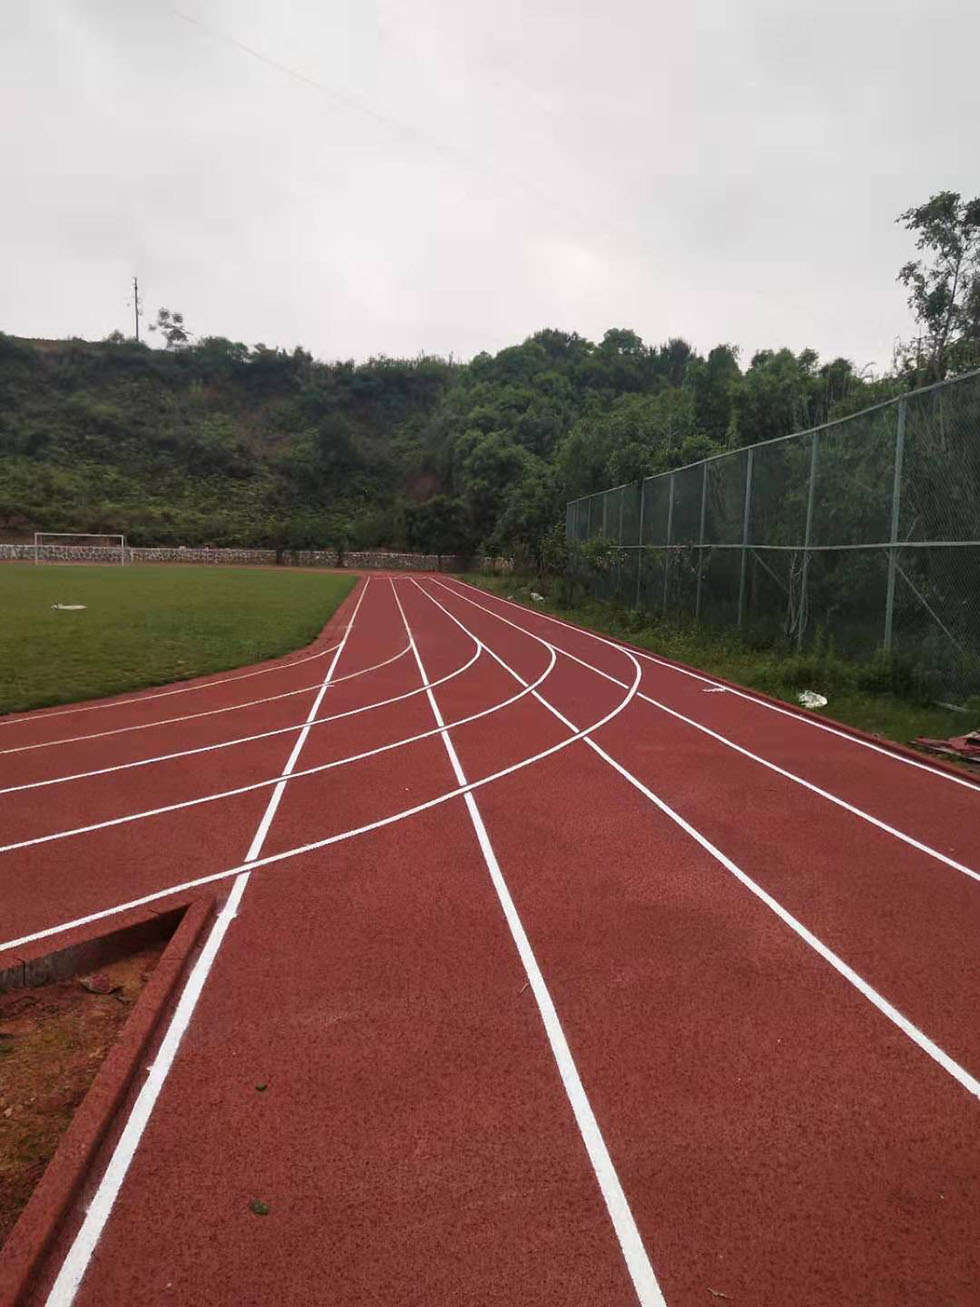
[0,637,640,949]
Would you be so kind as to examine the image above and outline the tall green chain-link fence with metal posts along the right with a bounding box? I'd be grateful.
[566,371,980,691]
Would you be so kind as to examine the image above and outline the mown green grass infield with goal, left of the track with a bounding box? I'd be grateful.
[0,563,355,714]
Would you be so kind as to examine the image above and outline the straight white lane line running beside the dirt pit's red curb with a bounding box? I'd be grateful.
[47,578,370,1307]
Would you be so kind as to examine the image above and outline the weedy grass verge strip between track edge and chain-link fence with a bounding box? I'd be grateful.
[465,574,980,775]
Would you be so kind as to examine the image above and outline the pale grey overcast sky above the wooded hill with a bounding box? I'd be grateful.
[0,0,980,367]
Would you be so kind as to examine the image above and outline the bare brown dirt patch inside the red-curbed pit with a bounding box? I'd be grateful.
[0,940,166,1246]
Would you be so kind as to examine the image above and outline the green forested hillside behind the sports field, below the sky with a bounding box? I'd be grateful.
[0,329,902,554]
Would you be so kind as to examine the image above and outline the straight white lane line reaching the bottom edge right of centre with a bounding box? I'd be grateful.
[392,584,666,1307]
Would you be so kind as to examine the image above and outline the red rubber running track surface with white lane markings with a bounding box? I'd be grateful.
[0,576,980,1307]
